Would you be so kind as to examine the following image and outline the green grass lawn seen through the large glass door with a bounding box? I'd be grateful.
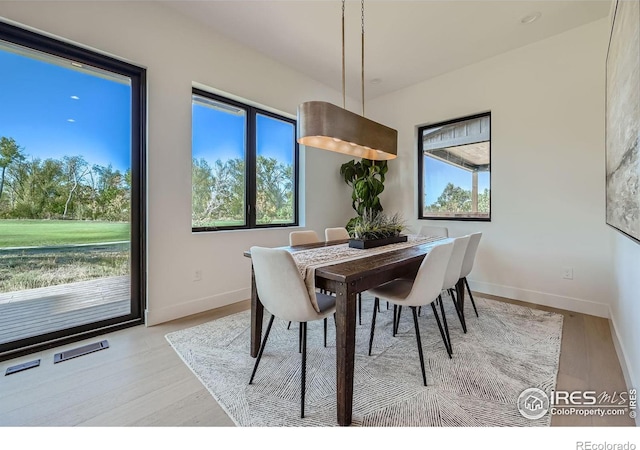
[0,219,129,248]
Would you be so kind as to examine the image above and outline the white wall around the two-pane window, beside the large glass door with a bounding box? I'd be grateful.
[0,1,352,325]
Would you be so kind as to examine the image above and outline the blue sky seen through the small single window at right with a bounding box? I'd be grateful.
[423,156,491,206]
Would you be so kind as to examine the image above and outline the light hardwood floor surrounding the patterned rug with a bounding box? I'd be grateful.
[0,294,634,427]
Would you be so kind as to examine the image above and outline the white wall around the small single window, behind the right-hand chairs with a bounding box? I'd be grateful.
[368,19,615,317]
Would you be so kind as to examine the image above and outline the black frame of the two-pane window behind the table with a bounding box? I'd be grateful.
[191,87,300,233]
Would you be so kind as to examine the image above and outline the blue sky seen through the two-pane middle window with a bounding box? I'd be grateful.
[192,103,296,165]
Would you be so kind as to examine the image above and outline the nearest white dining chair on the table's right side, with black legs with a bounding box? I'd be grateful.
[369,242,453,386]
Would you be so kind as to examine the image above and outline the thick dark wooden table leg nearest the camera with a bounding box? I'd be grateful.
[336,283,357,426]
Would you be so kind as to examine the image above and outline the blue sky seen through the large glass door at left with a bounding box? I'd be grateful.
[0,47,131,171]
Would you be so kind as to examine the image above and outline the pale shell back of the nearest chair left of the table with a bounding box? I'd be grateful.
[251,246,318,322]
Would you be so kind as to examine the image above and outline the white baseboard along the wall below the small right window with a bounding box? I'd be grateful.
[469,280,609,319]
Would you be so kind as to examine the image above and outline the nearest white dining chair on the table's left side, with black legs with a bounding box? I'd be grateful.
[249,246,336,418]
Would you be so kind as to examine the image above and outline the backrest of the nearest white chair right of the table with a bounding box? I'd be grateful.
[405,242,453,306]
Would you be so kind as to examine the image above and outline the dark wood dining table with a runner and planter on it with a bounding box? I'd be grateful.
[244,239,464,426]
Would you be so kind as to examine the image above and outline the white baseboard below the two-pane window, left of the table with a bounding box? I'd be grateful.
[145,288,251,326]
